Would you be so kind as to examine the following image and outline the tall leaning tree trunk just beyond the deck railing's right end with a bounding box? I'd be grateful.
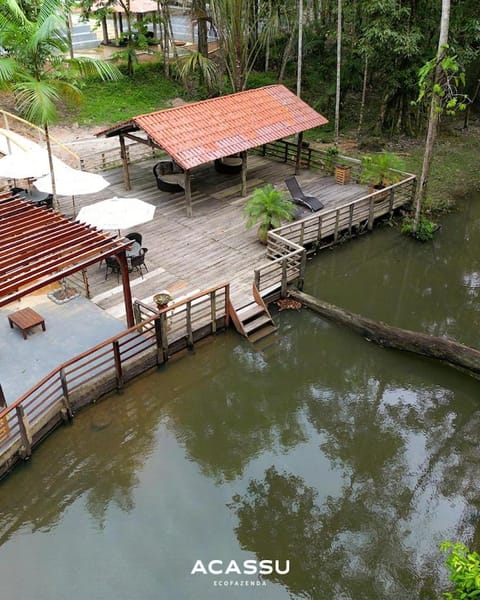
[413,0,450,232]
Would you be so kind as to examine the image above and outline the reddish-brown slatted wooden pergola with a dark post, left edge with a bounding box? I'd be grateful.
[0,193,135,327]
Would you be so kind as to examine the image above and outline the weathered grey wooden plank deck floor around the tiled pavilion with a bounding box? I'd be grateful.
[60,155,367,324]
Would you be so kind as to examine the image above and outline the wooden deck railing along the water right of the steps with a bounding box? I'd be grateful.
[254,175,416,297]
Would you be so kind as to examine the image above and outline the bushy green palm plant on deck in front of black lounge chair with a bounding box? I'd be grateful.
[243,184,296,244]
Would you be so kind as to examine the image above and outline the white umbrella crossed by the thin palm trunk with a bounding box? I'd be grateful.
[33,165,110,196]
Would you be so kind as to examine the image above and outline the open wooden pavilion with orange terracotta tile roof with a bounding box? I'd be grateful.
[97,85,328,216]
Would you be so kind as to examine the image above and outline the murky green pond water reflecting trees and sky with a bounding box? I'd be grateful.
[0,198,480,600]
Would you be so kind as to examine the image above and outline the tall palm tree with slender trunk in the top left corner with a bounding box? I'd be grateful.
[0,0,121,202]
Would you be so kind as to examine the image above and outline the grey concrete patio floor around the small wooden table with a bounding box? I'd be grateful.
[0,295,126,404]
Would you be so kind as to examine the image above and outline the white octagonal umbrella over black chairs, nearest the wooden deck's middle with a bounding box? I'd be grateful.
[77,196,155,235]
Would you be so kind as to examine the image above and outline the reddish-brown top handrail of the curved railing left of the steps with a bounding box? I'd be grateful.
[0,283,230,420]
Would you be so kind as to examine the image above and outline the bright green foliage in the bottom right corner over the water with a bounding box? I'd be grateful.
[440,542,480,600]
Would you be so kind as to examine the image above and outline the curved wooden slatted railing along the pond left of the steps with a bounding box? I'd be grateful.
[0,284,229,477]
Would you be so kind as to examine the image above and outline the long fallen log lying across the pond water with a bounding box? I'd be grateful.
[289,290,480,378]
